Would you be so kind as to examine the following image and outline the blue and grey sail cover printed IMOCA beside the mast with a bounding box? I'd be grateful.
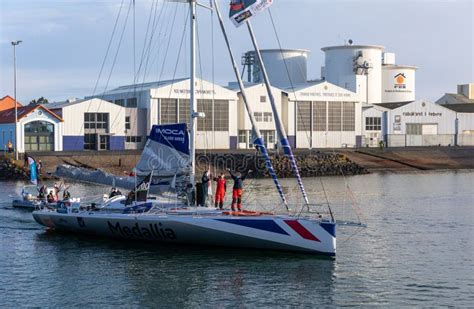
[135,123,191,177]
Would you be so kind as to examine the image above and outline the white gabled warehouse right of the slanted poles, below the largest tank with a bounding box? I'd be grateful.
[283,81,362,148]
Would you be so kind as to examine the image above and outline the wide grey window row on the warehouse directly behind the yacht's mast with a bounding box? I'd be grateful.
[160,99,229,131]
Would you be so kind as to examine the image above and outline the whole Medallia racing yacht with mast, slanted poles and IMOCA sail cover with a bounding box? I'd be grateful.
[33,0,336,256]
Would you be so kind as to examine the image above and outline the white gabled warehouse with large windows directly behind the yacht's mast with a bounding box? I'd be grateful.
[95,78,238,149]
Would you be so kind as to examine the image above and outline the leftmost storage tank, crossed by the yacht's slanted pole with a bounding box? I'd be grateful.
[242,49,309,88]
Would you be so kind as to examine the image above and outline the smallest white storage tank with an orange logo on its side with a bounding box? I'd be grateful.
[382,65,417,103]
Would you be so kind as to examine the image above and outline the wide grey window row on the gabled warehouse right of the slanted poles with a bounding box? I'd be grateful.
[296,101,355,132]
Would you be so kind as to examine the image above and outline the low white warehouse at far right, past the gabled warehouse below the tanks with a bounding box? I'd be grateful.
[363,100,474,147]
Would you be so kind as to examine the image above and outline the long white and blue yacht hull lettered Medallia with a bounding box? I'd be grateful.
[33,210,336,256]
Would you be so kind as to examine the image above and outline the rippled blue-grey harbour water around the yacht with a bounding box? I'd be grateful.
[0,171,474,308]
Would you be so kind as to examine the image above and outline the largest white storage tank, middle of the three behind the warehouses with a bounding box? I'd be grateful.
[322,45,385,103]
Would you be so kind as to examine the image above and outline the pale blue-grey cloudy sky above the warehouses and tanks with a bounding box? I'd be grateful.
[0,0,474,103]
